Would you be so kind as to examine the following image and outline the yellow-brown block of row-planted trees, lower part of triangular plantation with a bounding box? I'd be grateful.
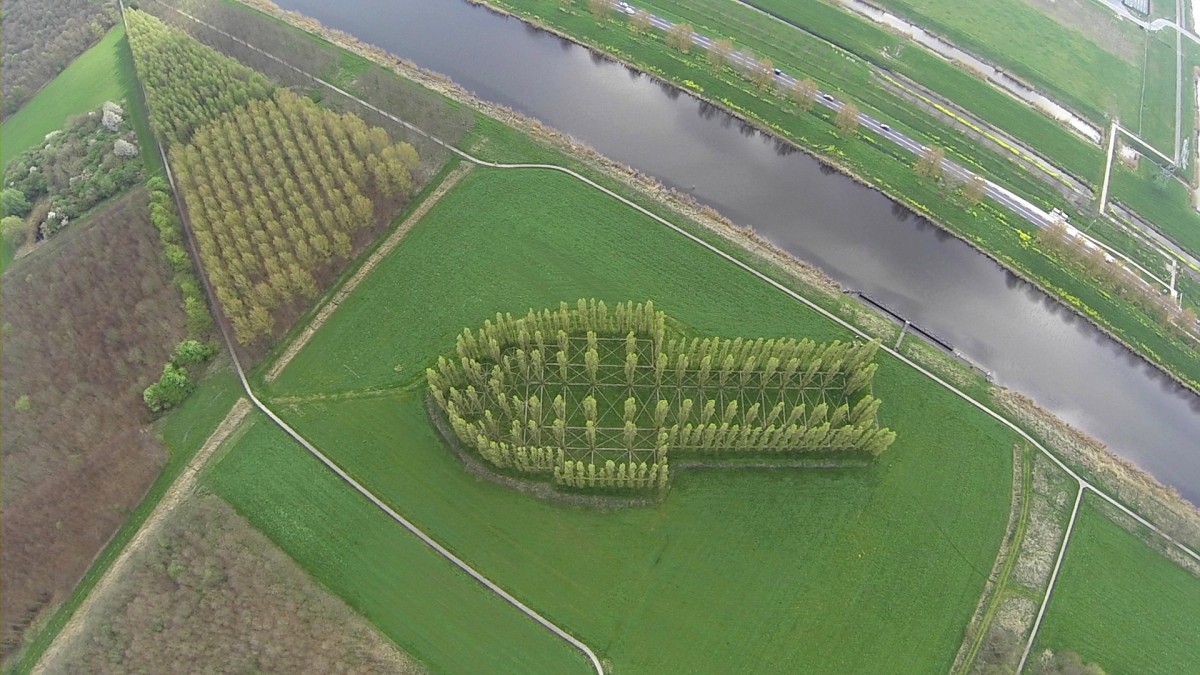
[170,90,420,344]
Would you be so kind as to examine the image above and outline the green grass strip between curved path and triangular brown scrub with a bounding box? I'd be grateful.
[204,413,587,673]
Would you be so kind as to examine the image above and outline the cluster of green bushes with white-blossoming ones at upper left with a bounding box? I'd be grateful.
[0,102,143,244]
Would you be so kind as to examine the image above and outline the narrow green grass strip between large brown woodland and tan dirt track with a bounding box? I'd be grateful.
[10,366,241,674]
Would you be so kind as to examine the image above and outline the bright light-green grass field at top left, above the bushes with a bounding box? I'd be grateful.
[0,24,162,270]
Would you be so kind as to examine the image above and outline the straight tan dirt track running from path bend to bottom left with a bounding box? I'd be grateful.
[34,399,252,674]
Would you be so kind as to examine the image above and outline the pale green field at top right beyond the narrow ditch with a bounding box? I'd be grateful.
[873,0,1152,124]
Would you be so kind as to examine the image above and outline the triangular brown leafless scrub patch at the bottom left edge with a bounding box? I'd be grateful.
[41,494,422,674]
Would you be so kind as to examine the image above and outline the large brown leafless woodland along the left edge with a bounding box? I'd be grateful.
[0,190,185,657]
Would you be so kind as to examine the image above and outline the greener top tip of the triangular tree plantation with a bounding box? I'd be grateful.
[125,10,274,145]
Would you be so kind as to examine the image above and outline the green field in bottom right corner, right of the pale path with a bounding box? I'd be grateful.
[1036,495,1200,674]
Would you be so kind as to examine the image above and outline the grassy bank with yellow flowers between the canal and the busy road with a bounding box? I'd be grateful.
[477,0,1200,388]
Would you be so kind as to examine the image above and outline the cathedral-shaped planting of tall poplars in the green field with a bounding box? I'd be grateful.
[426,300,895,490]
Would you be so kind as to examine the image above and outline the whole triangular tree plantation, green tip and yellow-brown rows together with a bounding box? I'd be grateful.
[127,11,420,345]
